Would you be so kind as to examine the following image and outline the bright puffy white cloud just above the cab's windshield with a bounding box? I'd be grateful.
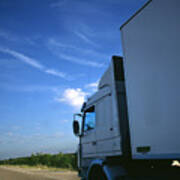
[56,88,87,108]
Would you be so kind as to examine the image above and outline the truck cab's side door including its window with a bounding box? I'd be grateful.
[81,106,96,157]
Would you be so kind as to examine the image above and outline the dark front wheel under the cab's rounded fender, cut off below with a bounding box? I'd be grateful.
[88,166,108,180]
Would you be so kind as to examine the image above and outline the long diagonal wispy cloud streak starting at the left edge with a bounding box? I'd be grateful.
[0,47,70,79]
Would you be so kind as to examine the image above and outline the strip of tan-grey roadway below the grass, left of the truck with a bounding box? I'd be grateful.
[0,166,79,180]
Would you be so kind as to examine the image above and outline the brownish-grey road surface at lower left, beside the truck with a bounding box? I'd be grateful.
[0,167,79,180]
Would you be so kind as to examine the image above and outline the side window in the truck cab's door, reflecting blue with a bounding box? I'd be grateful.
[84,106,96,132]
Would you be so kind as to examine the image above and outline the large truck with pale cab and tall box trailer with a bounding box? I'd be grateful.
[73,0,180,180]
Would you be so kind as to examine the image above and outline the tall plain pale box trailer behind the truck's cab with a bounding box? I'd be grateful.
[121,0,180,159]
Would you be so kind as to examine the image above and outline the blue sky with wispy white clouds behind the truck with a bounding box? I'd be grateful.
[0,0,147,159]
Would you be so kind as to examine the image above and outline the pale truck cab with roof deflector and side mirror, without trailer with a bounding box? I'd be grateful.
[74,56,130,179]
